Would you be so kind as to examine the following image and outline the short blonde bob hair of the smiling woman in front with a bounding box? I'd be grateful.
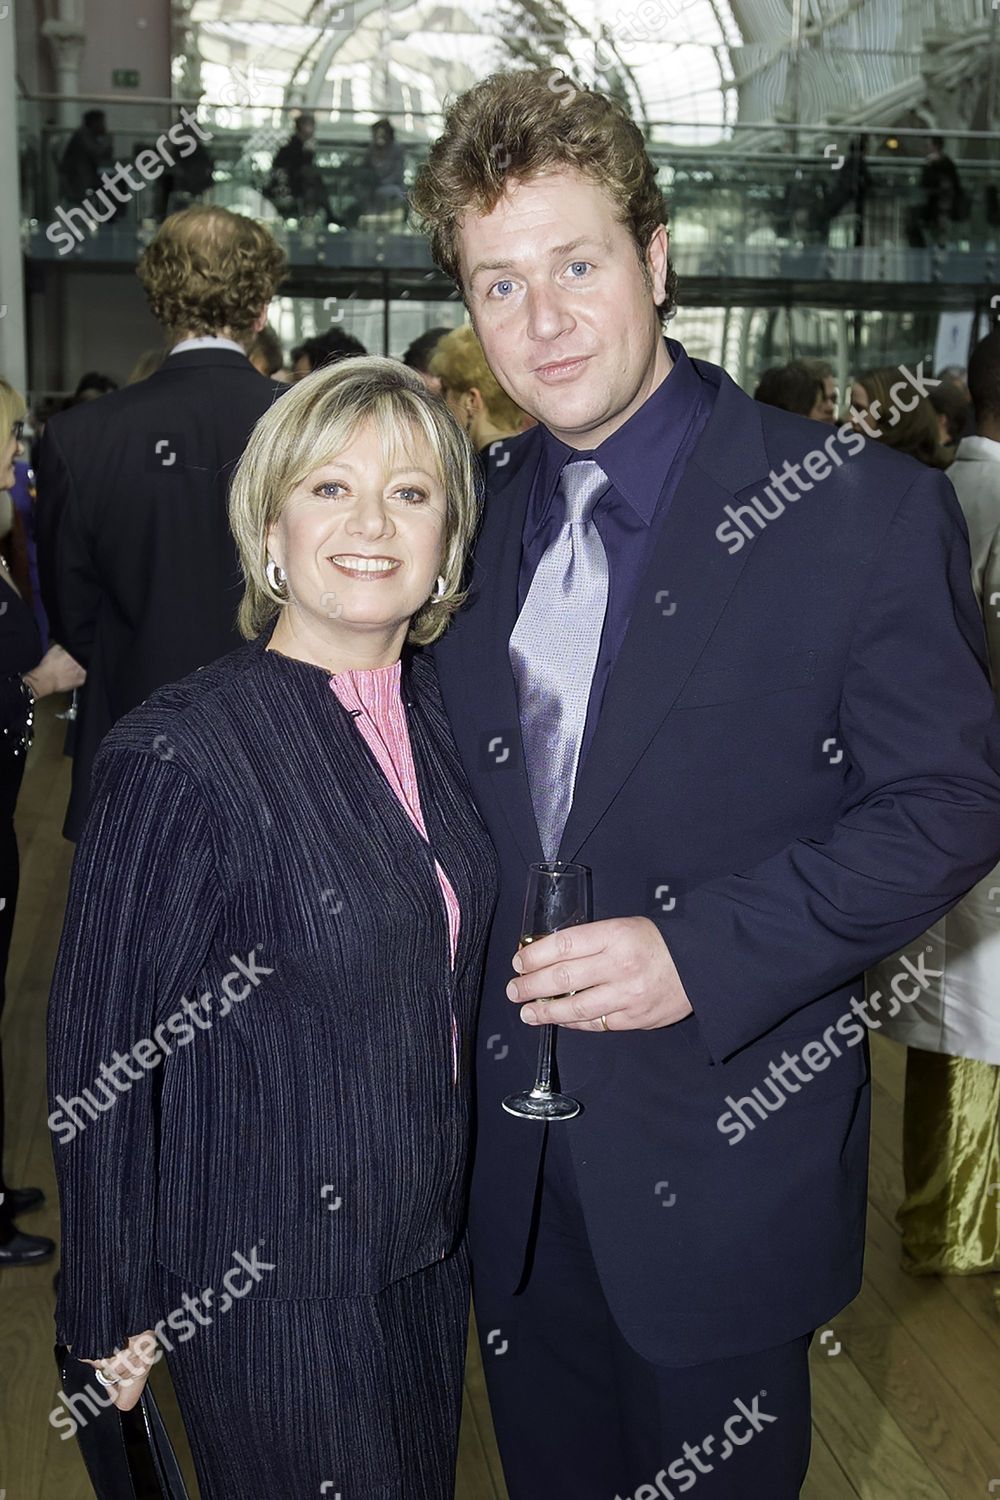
[229,354,481,647]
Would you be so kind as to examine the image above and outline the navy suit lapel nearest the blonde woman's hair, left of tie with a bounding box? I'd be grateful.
[444,428,543,864]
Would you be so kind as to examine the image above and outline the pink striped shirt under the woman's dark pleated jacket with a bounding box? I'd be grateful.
[330,662,462,1082]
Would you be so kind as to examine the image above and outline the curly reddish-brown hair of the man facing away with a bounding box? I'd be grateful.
[136,204,286,344]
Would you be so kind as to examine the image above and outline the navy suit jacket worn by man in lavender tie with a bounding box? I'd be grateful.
[436,362,1000,1365]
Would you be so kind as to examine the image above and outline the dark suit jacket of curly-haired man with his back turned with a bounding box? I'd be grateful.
[37,347,285,839]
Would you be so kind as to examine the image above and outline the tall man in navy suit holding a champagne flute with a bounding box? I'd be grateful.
[415,72,1000,1500]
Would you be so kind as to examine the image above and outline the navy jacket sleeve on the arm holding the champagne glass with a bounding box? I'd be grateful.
[663,473,1000,1062]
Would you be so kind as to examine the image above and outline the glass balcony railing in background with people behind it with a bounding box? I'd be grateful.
[19,101,1000,264]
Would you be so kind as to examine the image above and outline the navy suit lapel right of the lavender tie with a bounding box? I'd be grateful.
[559,370,768,860]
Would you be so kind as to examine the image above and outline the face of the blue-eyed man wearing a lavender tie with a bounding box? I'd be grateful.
[459,170,670,449]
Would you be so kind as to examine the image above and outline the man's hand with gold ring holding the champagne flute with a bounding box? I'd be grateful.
[507,917,691,1031]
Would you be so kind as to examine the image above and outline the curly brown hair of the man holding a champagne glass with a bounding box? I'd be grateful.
[411,69,678,321]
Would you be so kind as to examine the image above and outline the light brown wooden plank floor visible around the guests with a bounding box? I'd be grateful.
[0,701,1000,1500]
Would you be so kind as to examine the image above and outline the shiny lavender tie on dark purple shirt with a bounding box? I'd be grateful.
[510,459,610,860]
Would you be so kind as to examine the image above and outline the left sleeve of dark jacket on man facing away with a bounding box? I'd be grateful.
[34,419,102,666]
